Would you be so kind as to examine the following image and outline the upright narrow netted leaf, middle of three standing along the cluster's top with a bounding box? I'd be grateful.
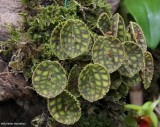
[111,13,125,42]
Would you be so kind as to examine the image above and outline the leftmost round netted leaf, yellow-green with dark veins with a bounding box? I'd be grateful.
[32,61,67,98]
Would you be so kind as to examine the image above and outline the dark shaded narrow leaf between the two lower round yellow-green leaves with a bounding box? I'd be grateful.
[67,65,82,97]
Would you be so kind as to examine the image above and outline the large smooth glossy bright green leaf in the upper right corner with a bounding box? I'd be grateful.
[121,0,160,49]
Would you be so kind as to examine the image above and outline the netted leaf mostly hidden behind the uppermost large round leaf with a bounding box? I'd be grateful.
[50,24,69,60]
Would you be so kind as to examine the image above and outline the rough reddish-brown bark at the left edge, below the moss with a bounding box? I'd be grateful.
[0,60,32,101]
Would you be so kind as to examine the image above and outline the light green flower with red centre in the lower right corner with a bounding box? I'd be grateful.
[124,100,160,127]
